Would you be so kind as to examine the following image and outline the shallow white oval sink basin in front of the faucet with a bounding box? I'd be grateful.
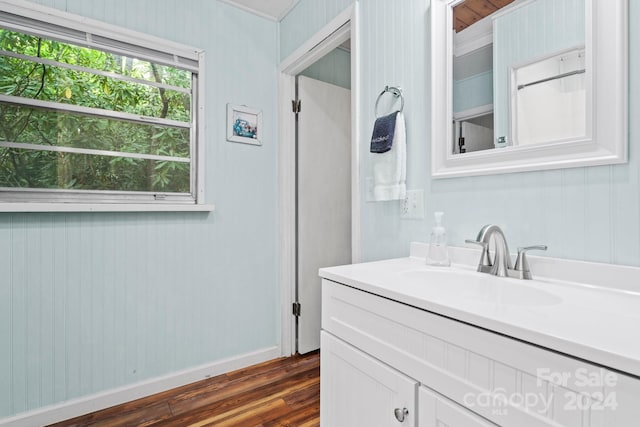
[398,268,562,306]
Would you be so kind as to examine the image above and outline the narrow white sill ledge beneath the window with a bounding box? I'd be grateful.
[0,202,215,212]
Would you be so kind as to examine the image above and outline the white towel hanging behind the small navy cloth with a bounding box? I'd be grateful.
[371,112,407,202]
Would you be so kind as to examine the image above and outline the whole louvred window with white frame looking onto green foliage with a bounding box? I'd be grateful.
[0,2,203,204]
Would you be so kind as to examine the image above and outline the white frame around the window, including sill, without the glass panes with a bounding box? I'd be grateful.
[0,0,213,212]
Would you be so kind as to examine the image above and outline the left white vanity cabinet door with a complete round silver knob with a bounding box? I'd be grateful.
[320,331,418,427]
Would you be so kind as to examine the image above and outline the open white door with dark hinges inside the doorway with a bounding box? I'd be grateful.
[296,76,351,353]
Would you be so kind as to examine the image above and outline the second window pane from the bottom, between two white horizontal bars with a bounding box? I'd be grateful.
[0,104,190,158]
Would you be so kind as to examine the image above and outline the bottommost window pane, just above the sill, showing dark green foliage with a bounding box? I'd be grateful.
[0,147,190,193]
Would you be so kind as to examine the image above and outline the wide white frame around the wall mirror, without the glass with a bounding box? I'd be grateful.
[431,0,628,178]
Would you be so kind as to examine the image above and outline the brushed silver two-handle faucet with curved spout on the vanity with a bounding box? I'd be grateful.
[466,224,547,280]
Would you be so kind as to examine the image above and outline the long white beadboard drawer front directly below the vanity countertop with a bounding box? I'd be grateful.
[322,280,640,427]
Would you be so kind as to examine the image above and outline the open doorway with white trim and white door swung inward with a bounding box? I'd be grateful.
[279,4,360,356]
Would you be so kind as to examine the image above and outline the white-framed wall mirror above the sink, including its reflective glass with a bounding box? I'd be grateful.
[431,0,628,178]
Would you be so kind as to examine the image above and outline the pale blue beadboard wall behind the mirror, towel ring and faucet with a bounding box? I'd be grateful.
[280,0,640,266]
